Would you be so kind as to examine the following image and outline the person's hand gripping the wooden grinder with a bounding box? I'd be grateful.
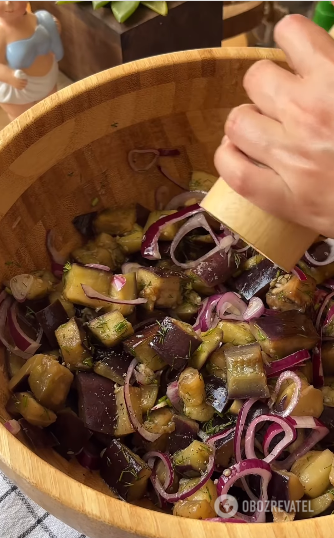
[215,15,334,237]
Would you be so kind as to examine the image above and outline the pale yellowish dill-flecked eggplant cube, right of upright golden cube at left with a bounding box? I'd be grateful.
[88,310,133,347]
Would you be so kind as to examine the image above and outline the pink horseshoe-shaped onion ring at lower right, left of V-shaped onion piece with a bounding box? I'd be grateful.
[245,415,297,463]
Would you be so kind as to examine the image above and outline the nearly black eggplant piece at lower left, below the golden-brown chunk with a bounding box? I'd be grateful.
[50,408,92,457]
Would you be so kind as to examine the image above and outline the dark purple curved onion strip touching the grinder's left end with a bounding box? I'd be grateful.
[141,204,204,260]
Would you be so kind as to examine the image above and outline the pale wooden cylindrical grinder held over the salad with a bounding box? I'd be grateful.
[201,178,318,271]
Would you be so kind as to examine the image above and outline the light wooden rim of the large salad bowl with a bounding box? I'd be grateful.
[0,48,333,538]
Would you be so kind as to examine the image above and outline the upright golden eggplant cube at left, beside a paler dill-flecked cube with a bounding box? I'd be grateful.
[55,318,92,370]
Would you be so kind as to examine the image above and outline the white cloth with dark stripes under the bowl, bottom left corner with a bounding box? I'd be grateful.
[0,472,87,538]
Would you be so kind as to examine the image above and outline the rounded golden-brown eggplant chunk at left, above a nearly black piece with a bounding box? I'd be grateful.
[28,355,74,411]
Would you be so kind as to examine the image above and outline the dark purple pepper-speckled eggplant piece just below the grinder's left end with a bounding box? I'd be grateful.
[187,250,237,287]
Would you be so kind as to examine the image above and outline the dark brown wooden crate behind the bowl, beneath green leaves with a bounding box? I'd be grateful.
[31,1,223,80]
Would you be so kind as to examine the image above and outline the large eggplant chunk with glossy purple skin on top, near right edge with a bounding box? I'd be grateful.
[250,310,319,359]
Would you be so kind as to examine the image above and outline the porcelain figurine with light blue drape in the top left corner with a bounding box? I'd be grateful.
[0,2,64,120]
